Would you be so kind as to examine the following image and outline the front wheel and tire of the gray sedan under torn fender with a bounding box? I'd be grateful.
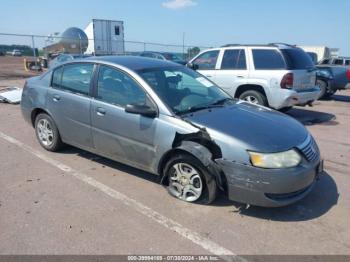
[163,154,217,204]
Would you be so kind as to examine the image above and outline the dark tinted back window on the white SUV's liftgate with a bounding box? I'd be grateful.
[281,48,315,70]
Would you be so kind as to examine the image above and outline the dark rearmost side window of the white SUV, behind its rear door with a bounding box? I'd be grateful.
[252,49,286,70]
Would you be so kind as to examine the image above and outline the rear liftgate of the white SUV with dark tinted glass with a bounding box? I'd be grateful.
[281,48,316,90]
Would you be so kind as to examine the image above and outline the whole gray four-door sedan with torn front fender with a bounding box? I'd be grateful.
[21,57,322,206]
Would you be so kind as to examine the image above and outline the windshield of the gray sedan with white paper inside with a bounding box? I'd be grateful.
[138,67,232,114]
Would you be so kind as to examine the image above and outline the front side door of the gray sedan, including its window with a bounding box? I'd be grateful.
[91,65,159,170]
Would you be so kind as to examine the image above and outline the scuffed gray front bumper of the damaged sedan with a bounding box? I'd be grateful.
[216,159,323,207]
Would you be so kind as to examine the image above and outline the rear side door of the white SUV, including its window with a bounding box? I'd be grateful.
[213,47,249,96]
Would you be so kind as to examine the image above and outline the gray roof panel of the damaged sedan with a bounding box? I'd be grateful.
[81,56,180,71]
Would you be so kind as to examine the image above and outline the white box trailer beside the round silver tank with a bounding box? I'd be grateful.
[85,19,124,55]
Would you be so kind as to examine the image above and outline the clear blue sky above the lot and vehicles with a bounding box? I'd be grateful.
[0,0,350,55]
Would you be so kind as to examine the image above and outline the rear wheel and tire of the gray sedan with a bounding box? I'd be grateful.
[35,113,64,152]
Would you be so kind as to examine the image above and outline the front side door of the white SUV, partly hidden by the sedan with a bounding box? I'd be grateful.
[192,50,220,80]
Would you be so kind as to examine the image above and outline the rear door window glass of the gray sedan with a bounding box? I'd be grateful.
[57,63,94,95]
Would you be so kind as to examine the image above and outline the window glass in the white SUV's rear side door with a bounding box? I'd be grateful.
[221,49,247,70]
